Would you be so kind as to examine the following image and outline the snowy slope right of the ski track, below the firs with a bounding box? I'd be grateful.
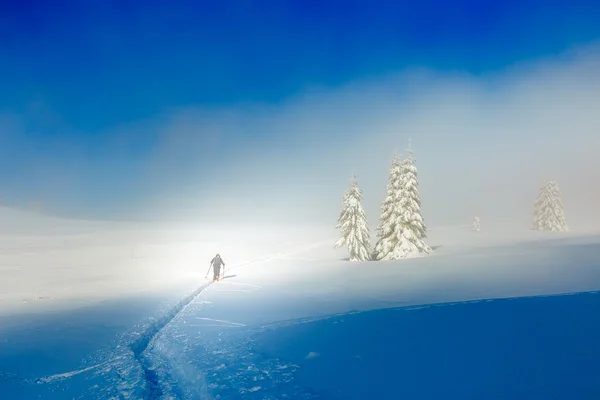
[125,237,600,399]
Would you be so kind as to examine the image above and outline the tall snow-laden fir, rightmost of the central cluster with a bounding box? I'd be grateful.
[394,146,431,258]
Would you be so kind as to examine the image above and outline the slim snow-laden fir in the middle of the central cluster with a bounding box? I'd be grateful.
[372,153,402,261]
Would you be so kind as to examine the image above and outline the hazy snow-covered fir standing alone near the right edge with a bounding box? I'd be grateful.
[532,181,569,232]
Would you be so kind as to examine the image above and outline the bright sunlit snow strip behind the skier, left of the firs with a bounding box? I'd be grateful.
[0,208,327,314]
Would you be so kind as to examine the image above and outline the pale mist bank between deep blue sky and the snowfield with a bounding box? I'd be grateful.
[0,44,600,230]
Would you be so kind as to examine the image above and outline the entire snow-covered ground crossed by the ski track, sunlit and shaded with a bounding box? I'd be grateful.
[0,211,600,399]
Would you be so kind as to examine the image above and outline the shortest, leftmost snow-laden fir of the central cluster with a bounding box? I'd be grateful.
[335,176,371,261]
